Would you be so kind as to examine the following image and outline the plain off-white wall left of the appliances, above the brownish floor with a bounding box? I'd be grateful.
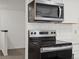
[0,0,25,49]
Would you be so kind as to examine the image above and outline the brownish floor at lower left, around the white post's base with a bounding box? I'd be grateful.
[0,49,25,59]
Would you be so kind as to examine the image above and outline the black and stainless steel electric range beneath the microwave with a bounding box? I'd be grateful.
[28,30,72,59]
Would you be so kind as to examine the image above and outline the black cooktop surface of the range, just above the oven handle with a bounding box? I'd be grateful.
[32,40,72,47]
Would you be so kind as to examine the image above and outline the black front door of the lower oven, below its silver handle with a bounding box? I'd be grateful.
[41,47,72,59]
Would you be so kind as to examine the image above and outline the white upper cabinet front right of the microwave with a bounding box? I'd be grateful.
[64,0,79,23]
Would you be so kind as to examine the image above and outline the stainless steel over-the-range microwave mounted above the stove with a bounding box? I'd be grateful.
[28,0,64,22]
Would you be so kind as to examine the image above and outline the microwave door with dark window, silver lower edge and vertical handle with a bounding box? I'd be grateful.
[35,3,64,21]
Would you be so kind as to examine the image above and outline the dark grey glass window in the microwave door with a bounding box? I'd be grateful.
[36,4,59,18]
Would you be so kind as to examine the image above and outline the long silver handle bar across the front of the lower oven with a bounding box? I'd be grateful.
[40,46,72,53]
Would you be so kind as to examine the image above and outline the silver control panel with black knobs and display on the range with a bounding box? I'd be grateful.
[29,30,56,37]
